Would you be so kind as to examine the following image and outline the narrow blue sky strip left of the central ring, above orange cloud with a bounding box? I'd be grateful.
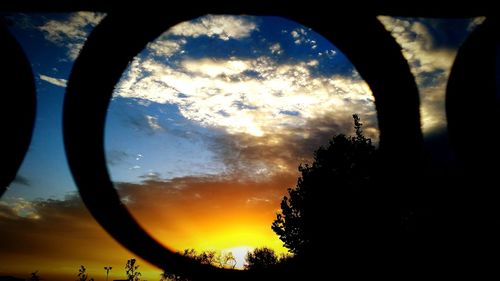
[4,14,105,200]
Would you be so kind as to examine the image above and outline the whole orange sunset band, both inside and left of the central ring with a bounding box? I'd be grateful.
[0,175,296,280]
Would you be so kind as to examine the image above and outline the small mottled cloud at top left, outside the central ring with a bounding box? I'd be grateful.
[38,12,105,60]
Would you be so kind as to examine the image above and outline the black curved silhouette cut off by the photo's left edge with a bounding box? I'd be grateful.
[0,19,36,197]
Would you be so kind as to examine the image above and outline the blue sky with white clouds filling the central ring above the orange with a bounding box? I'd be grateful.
[107,16,374,186]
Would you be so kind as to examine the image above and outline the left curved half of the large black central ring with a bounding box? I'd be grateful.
[63,14,254,280]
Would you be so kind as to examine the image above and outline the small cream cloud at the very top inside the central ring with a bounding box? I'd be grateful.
[169,15,258,41]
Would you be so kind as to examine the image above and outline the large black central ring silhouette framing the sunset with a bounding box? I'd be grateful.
[63,8,422,280]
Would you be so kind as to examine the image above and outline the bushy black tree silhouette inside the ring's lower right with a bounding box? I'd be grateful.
[272,114,376,256]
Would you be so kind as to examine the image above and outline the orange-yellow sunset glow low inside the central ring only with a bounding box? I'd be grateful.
[117,175,296,250]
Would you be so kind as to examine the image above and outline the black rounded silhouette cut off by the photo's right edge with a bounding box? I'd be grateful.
[446,18,500,241]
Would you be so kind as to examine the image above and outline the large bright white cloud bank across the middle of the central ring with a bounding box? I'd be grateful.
[114,16,378,177]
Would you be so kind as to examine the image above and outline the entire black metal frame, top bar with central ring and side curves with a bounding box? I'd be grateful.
[0,1,499,280]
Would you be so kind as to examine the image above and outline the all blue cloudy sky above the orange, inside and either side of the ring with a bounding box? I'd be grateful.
[0,12,480,200]
